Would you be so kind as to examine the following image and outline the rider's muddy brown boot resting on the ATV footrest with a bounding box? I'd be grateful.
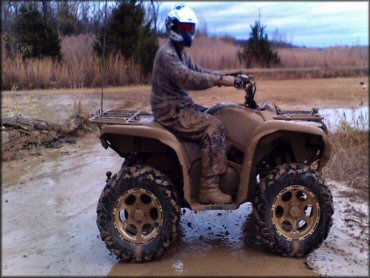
[198,175,232,204]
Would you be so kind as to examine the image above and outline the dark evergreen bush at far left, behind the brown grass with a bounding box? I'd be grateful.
[13,5,61,60]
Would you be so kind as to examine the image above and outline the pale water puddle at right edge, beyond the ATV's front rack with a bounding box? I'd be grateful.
[319,106,369,131]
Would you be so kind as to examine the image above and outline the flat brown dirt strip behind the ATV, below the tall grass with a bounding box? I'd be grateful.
[2,77,369,123]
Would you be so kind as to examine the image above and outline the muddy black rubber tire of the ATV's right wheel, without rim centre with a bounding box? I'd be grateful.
[254,163,334,257]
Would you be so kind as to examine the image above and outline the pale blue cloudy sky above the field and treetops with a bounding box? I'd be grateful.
[161,1,369,47]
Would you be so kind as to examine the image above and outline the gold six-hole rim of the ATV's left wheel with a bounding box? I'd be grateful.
[113,188,163,244]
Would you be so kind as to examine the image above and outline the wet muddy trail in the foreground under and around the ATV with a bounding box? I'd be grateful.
[2,133,369,276]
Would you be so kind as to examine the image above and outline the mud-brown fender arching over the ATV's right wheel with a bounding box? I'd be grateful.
[237,120,331,203]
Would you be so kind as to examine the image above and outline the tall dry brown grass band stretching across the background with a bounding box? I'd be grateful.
[2,35,368,90]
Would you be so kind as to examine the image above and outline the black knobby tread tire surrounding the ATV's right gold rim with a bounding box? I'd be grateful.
[253,163,334,257]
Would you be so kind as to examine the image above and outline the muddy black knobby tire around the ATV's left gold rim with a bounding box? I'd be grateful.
[96,165,180,262]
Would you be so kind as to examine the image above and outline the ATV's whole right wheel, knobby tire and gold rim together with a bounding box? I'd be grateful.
[254,164,334,257]
